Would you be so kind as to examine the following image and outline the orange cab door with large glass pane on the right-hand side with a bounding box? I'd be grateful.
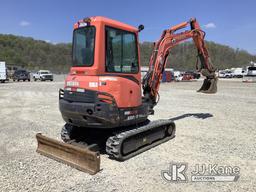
[99,26,141,107]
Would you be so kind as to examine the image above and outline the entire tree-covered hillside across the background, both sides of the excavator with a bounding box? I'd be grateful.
[0,34,256,73]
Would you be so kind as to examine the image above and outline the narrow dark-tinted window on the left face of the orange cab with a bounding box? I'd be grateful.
[72,26,95,67]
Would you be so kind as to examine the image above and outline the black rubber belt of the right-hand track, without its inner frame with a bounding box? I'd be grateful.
[106,120,175,161]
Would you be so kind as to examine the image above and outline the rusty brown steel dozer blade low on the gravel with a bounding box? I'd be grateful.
[36,133,100,175]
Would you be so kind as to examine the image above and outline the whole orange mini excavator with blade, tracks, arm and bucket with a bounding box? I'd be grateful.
[37,16,217,173]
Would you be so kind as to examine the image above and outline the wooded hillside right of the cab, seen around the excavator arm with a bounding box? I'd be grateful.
[140,41,256,70]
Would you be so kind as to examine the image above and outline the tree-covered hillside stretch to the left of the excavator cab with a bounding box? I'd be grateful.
[0,35,71,72]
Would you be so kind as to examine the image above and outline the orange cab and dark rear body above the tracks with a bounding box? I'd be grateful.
[59,16,145,129]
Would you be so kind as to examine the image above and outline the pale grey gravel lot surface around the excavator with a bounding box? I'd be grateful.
[0,77,256,192]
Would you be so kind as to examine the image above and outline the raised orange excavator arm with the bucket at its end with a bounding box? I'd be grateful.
[143,18,217,105]
